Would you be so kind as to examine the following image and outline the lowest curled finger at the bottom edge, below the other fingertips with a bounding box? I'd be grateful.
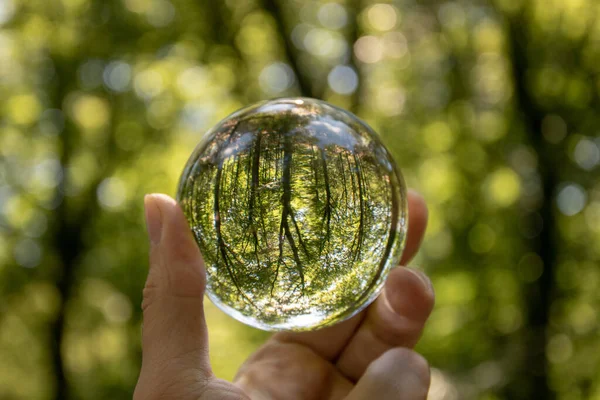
[346,348,430,400]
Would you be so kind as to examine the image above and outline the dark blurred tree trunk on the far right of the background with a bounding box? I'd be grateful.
[508,16,558,400]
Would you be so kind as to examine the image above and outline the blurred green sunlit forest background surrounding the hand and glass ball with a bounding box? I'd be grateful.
[0,0,600,400]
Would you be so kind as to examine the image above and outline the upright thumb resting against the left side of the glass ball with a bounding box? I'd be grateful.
[136,194,212,398]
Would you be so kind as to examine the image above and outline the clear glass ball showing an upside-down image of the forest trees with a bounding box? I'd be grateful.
[177,98,407,331]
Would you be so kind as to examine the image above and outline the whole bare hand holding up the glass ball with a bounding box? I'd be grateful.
[134,192,434,400]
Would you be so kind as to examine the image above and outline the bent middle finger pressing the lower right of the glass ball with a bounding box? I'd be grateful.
[337,268,434,381]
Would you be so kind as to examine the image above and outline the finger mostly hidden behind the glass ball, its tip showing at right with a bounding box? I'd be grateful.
[273,190,427,360]
